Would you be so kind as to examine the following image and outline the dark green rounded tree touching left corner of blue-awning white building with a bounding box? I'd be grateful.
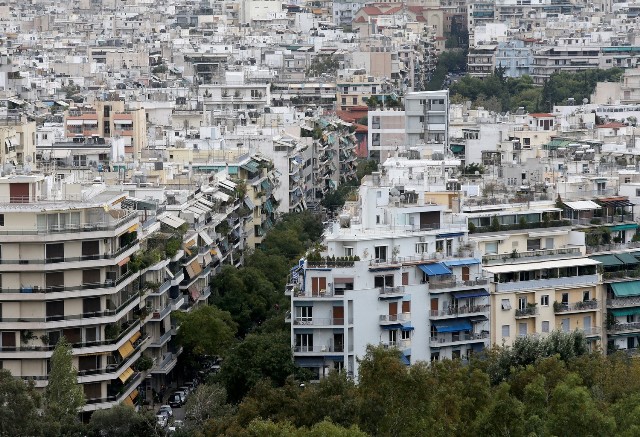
[220,332,296,401]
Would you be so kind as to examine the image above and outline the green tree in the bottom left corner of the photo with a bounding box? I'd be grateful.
[0,369,43,436]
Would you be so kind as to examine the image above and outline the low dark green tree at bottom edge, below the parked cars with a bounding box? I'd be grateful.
[88,404,162,437]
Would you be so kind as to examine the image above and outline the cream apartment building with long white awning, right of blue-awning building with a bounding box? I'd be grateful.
[467,204,604,350]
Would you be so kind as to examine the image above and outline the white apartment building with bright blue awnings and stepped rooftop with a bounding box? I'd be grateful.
[286,173,489,378]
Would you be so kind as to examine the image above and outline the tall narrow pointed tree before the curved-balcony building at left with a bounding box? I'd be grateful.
[44,337,85,427]
